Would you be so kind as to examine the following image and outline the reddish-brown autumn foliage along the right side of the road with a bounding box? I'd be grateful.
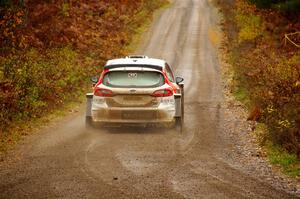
[218,0,300,157]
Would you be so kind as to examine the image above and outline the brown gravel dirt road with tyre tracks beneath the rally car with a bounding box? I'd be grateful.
[0,0,296,199]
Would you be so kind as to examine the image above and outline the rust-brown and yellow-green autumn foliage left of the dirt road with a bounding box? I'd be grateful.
[0,0,164,142]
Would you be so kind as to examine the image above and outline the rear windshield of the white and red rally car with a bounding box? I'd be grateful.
[103,71,164,88]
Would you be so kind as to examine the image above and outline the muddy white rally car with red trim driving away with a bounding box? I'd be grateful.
[86,55,184,126]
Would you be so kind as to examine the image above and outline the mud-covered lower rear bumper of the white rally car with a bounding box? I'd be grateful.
[91,106,175,123]
